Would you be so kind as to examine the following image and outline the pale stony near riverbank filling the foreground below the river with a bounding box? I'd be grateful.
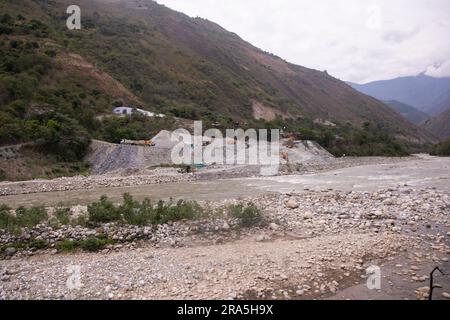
[0,187,450,299]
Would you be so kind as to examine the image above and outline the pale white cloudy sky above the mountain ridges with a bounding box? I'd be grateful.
[157,0,450,83]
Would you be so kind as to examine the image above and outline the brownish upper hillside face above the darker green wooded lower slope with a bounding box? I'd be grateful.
[2,0,433,143]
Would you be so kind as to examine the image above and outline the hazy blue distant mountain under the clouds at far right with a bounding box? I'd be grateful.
[349,74,450,115]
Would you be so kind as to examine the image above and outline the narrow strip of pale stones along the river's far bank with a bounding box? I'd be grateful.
[0,157,415,196]
